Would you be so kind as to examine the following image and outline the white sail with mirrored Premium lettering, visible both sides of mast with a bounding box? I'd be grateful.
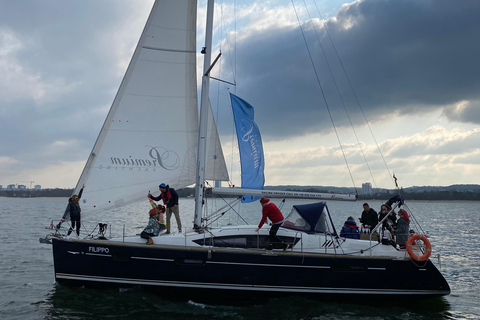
[76,0,228,212]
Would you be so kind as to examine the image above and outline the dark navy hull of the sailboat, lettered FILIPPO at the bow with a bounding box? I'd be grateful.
[53,239,450,298]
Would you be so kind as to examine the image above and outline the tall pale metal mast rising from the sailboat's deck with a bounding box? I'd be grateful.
[193,0,214,230]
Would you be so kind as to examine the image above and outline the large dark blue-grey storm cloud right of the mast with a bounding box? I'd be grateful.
[224,0,480,139]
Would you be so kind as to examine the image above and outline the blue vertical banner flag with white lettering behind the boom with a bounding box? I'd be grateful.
[230,93,265,202]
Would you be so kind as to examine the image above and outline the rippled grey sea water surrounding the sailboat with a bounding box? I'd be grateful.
[0,198,480,320]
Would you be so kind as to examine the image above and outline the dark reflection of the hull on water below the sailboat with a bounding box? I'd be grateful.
[41,285,454,320]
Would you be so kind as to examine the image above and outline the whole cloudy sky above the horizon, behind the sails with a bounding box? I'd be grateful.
[0,0,480,188]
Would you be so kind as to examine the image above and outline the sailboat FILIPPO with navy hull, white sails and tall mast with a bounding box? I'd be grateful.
[47,0,450,298]
